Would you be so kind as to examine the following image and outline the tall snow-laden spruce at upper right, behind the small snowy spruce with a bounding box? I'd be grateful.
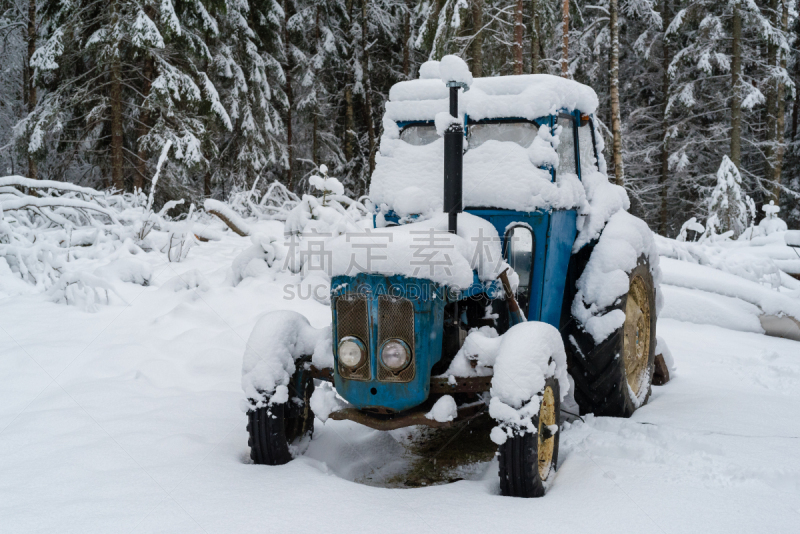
[667,0,790,228]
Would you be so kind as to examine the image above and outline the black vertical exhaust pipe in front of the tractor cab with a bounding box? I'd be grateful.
[444,82,466,234]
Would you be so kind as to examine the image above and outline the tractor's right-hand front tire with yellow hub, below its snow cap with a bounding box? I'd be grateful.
[498,378,561,497]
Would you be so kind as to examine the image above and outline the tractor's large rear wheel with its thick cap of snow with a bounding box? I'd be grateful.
[561,211,661,417]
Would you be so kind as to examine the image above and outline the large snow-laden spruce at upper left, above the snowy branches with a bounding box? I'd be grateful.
[15,0,229,190]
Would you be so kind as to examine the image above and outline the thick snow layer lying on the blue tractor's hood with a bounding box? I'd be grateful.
[328,213,508,289]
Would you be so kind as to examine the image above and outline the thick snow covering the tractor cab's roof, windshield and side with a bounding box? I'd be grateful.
[369,73,629,250]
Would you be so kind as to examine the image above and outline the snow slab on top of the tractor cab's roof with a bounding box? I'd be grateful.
[386,73,598,122]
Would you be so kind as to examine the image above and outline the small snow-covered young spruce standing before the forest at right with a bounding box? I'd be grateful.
[706,156,747,238]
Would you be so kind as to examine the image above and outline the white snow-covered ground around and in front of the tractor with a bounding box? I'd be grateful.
[0,222,800,533]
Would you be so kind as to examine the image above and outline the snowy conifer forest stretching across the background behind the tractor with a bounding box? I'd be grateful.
[0,0,800,237]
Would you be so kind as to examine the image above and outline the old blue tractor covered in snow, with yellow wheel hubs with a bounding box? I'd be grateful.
[243,56,660,497]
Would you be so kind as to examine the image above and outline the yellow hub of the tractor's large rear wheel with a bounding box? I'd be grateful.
[622,276,650,396]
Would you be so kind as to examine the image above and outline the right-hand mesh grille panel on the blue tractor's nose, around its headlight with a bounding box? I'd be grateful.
[377,296,416,382]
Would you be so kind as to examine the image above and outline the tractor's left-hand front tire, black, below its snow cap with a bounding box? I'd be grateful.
[247,358,314,465]
